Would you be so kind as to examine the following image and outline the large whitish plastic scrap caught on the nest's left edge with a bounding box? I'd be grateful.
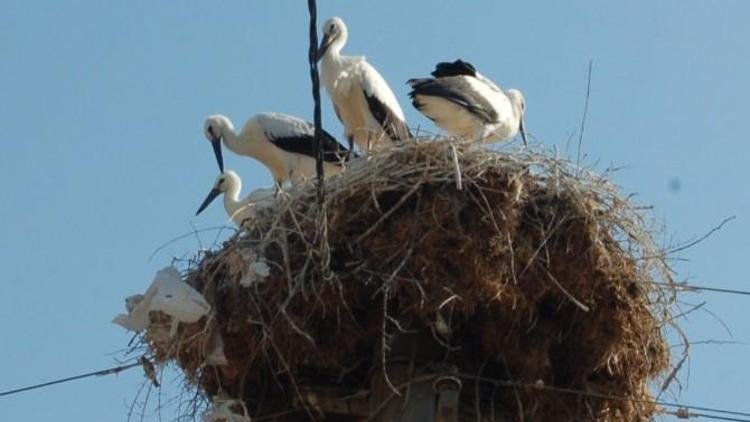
[112,266,211,337]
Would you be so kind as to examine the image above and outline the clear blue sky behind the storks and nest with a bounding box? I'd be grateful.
[0,0,750,421]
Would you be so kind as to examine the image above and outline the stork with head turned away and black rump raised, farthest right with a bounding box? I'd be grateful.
[408,60,526,145]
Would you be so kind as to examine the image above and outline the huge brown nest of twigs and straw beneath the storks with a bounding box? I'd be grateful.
[145,140,674,421]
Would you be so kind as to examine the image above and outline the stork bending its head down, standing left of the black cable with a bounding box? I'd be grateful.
[204,113,349,186]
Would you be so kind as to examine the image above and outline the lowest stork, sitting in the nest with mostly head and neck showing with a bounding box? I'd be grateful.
[195,170,275,227]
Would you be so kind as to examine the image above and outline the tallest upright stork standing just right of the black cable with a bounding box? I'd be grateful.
[318,17,412,155]
